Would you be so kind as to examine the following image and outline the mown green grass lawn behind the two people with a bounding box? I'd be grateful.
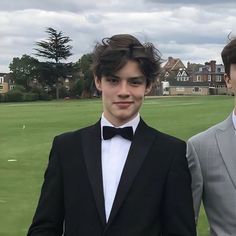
[0,96,234,236]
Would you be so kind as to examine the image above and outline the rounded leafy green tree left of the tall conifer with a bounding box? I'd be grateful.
[9,54,39,90]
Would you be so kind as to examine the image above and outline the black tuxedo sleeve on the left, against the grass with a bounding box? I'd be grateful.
[27,138,64,236]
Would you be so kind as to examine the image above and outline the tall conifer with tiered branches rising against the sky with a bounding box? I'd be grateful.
[35,27,72,99]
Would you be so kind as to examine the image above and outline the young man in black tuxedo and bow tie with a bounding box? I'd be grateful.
[28,35,195,236]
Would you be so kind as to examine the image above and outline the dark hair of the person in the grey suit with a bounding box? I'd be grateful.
[221,37,236,76]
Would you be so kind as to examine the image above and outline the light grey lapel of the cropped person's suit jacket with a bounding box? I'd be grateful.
[216,120,236,188]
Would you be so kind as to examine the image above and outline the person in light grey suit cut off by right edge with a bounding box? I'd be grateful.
[187,38,236,236]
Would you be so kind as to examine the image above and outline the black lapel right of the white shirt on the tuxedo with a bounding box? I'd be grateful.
[107,120,155,227]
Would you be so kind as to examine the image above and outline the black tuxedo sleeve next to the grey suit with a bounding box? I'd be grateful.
[163,142,196,236]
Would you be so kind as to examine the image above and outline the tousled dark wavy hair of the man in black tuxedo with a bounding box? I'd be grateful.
[92,34,161,85]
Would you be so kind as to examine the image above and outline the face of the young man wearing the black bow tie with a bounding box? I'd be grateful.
[95,61,151,126]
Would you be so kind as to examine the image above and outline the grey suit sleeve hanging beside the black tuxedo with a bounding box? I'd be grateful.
[187,140,203,224]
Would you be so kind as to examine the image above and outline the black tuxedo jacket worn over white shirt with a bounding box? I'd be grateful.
[28,120,196,236]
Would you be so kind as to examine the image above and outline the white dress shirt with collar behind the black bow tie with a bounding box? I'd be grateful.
[101,114,140,221]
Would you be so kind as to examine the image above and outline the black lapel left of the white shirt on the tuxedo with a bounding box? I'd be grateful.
[81,122,106,225]
